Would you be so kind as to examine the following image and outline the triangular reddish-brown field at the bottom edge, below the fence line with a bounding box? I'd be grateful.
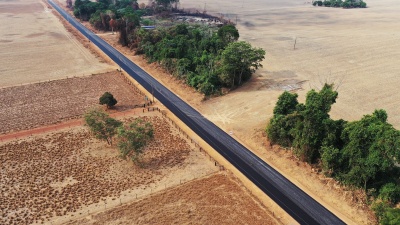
[68,173,276,225]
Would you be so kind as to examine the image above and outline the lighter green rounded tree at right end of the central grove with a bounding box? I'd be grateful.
[219,41,265,88]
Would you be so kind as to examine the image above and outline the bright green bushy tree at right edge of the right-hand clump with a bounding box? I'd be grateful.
[341,110,400,190]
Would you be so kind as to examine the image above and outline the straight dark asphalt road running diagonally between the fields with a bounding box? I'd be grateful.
[48,0,345,225]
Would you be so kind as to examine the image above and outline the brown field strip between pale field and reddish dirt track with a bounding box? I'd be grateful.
[0,72,144,134]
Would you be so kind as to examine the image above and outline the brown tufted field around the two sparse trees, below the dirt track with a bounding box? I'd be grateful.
[0,112,218,224]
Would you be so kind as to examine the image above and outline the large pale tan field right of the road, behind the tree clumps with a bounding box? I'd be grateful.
[180,0,400,128]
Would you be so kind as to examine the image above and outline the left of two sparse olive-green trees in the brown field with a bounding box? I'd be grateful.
[84,109,122,145]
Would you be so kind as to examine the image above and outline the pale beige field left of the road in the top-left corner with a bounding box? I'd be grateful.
[0,0,111,87]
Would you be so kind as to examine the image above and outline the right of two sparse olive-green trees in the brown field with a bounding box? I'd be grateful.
[117,119,154,162]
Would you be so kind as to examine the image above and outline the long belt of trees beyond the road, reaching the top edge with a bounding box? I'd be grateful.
[74,0,265,95]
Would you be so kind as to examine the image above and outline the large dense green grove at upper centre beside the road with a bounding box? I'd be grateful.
[135,24,265,95]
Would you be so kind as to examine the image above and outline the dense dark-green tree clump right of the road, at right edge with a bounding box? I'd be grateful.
[266,84,400,224]
